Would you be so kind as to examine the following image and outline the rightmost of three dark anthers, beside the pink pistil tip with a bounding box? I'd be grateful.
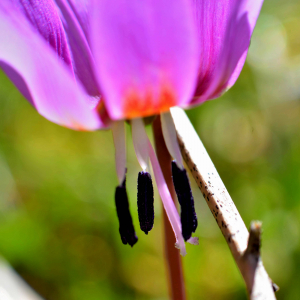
[172,161,198,241]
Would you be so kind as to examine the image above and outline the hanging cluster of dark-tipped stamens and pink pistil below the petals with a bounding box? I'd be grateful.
[112,113,197,255]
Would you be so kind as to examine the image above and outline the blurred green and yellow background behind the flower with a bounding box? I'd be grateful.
[0,0,300,300]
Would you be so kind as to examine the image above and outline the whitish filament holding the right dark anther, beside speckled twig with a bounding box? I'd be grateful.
[160,112,184,170]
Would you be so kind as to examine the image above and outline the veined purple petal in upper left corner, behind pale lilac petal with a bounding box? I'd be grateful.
[11,0,72,68]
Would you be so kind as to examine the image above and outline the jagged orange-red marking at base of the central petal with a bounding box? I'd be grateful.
[123,87,176,119]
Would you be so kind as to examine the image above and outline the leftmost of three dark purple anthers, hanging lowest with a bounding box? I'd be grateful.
[115,178,138,247]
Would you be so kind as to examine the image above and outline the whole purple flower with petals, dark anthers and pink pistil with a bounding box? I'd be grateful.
[0,0,263,255]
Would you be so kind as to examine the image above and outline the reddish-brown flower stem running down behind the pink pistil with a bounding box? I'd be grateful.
[153,117,186,300]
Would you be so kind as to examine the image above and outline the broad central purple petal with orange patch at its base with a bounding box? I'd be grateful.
[91,0,198,119]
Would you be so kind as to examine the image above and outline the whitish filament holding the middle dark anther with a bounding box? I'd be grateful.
[131,119,149,171]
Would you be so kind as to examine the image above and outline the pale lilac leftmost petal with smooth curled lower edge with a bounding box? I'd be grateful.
[0,2,103,130]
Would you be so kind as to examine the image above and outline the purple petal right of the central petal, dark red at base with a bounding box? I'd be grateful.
[191,0,263,105]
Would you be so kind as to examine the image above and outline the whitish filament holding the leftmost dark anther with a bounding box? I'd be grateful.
[111,121,126,186]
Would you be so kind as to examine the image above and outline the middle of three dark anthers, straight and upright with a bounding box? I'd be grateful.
[137,172,154,234]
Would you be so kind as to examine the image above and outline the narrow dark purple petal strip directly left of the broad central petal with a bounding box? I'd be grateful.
[55,0,100,96]
